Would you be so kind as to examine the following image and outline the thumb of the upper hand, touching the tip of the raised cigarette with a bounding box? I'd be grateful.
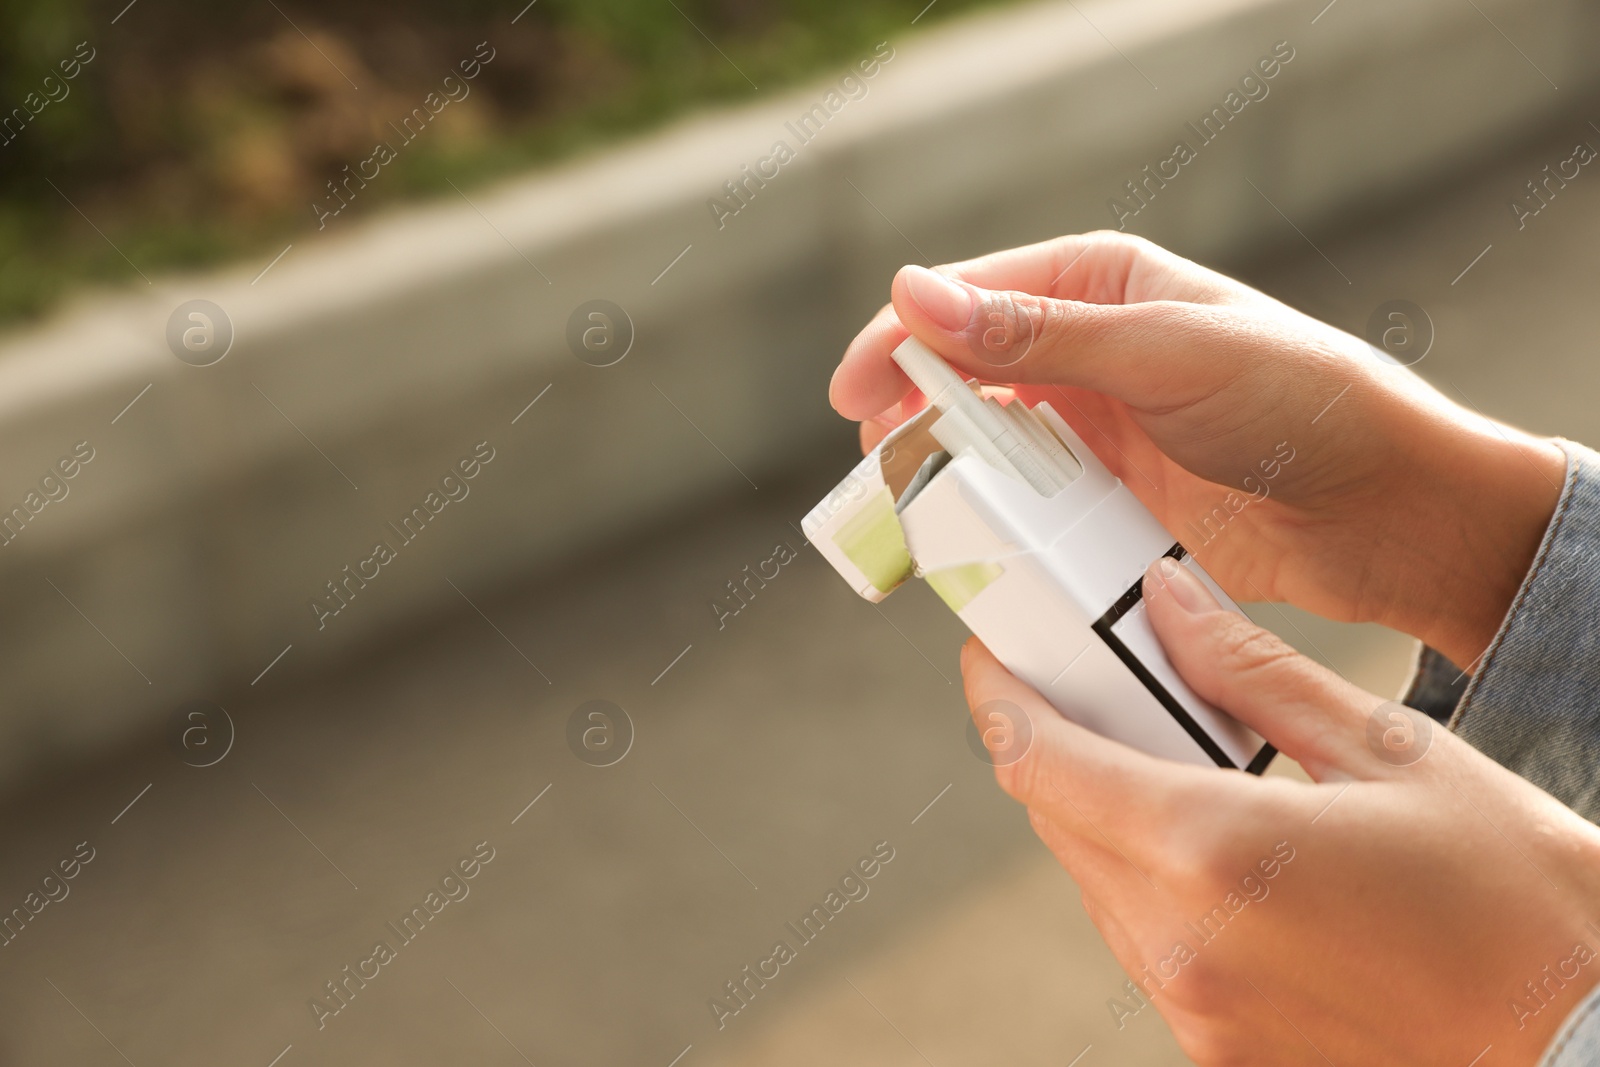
[891,266,1235,410]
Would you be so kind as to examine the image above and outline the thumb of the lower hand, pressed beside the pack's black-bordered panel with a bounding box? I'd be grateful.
[1144,557,1382,781]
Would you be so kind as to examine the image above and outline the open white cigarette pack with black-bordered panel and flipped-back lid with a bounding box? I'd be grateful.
[803,363,1275,774]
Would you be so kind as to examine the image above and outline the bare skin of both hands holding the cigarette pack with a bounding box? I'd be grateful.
[832,234,1600,1067]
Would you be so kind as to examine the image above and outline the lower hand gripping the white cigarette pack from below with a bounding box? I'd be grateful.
[962,561,1600,1067]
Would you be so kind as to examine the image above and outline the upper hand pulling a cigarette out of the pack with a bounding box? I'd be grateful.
[832,232,1565,665]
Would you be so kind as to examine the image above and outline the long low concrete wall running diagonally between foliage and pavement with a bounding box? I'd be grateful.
[0,0,1595,776]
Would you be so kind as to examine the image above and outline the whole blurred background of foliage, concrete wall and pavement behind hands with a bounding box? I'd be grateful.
[0,0,1600,1067]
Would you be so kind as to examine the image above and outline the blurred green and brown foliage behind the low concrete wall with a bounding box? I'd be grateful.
[0,0,1002,326]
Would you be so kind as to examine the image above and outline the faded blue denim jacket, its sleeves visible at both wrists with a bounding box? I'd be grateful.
[1405,442,1600,1067]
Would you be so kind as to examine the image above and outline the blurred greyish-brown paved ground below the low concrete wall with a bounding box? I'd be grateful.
[0,106,1600,1067]
